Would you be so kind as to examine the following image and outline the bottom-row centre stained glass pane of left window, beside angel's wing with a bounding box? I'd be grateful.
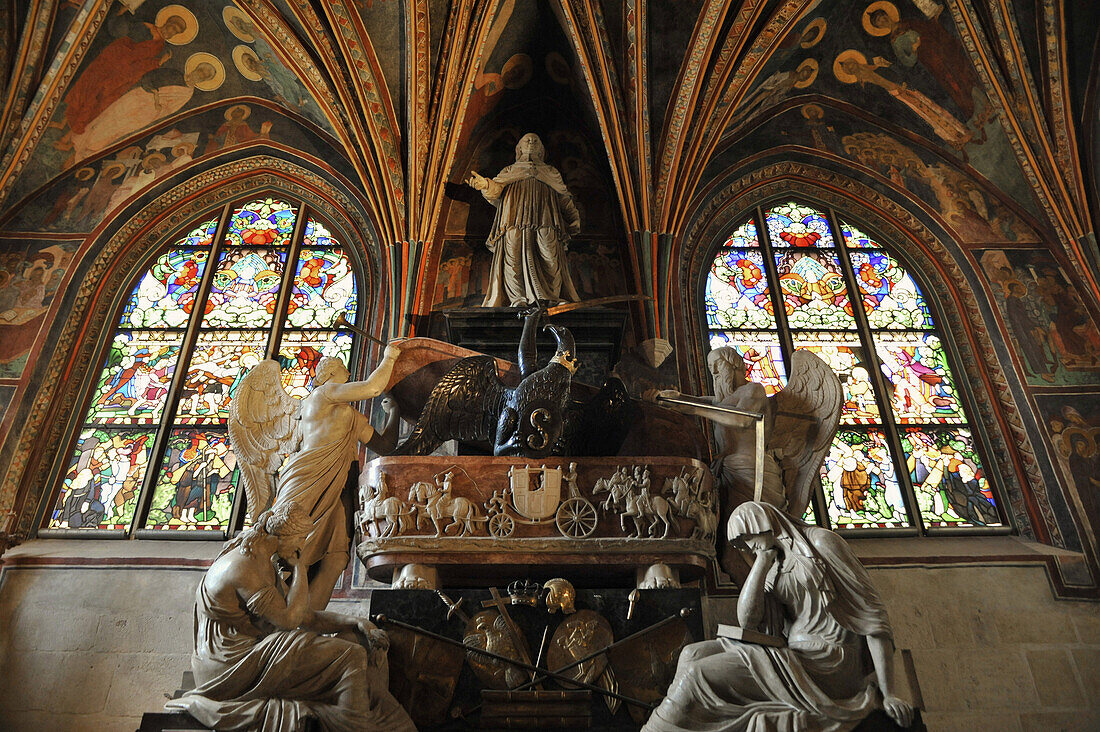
[144,429,239,532]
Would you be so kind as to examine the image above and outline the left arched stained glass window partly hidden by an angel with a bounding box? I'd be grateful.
[43,196,359,537]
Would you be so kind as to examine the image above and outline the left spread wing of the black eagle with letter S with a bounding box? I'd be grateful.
[394,356,507,455]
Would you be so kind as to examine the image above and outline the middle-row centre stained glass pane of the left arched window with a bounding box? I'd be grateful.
[176,330,267,425]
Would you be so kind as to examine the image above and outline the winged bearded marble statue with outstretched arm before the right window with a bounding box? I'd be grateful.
[659,347,844,575]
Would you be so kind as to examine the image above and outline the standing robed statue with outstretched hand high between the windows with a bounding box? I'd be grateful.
[466,132,581,307]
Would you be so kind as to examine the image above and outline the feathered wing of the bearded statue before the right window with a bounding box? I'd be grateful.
[766,350,844,517]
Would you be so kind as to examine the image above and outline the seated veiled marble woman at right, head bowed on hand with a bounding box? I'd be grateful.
[642,501,913,732]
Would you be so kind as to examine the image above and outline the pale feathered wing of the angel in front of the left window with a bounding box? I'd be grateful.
[229,359,299,518]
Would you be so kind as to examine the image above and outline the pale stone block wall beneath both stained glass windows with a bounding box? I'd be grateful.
[0,539,1100,732]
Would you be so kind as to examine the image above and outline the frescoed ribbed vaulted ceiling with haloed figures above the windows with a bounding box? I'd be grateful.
[0,0,1098,319]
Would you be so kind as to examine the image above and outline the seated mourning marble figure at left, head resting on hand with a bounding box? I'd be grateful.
[166,502,416,732]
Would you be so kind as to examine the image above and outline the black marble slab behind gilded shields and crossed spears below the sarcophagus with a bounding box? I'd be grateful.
[371,588,704,732]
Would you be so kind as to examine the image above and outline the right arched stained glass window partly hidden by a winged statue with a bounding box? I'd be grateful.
[705,200,1004,532]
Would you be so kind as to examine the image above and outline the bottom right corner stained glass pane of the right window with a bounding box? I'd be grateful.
[902,428,1001,527]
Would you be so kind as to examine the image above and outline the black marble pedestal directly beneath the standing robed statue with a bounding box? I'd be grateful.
[442,307,630,386]
